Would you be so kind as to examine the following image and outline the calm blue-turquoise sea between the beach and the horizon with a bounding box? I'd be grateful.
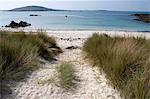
[0,11,150,31]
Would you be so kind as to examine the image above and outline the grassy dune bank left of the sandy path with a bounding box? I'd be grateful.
[0,31,61,95]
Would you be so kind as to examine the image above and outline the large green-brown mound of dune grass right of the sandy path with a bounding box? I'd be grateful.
[83,34,150,99]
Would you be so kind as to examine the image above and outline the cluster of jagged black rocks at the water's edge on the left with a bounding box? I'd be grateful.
[5,21,31,28]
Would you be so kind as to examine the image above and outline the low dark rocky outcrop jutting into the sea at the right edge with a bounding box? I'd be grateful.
[132,14,150,23]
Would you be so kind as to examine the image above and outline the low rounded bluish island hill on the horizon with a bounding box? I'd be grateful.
[8,6,64,11]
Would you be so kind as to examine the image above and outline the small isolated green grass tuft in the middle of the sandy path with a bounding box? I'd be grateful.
[58,62,75,90]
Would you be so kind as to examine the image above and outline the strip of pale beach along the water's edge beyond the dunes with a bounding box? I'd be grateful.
[0,28,150,39]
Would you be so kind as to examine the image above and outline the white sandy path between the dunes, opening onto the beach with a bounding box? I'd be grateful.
[2,31,150,99]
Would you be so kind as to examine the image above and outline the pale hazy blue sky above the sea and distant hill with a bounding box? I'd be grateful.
[0,0,150,11]
